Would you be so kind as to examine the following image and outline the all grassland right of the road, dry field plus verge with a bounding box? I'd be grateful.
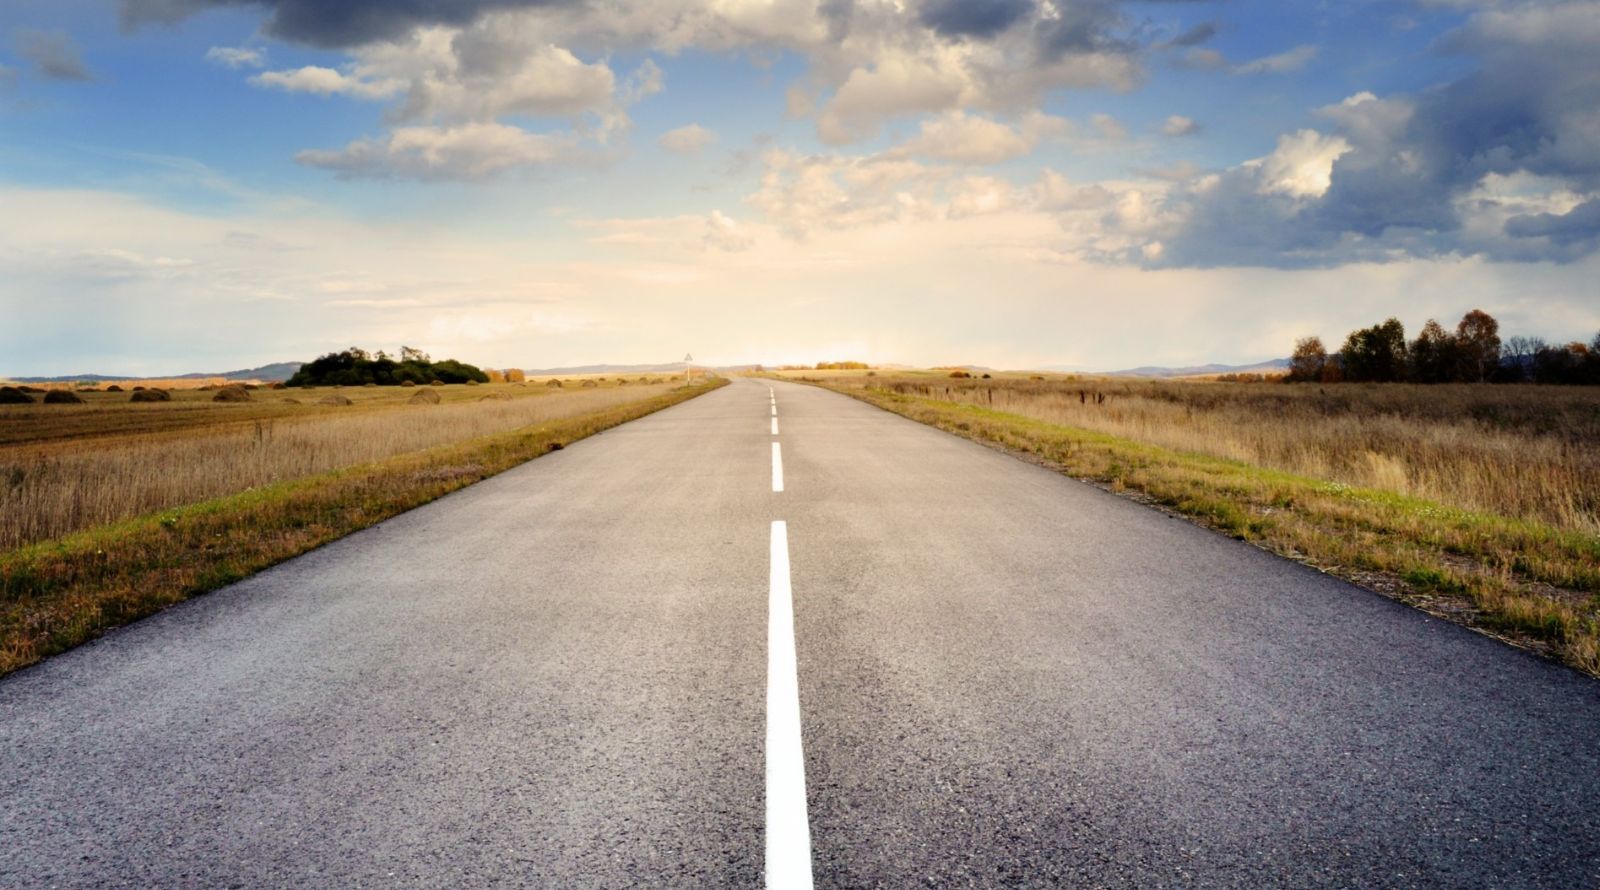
[784,371,1600,676]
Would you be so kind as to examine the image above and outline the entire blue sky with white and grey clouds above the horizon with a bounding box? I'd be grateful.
[0,0,1600,376]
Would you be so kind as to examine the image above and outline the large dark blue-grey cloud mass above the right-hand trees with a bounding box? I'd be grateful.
[1154,0,1600,267]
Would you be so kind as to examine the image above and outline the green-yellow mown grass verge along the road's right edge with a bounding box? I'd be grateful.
[819,383,1600,677]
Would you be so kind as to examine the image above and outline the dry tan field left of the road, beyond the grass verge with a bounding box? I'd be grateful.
[0,381,670,552]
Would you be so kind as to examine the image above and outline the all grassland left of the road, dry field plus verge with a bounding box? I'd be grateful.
[0,378,726,674]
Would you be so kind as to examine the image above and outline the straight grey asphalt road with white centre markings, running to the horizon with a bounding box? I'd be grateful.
[0,381,1600,888]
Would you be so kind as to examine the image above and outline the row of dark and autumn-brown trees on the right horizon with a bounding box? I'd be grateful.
[1286,309,1600,384]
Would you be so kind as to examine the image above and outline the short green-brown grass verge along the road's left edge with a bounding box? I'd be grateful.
[0,379,726,676]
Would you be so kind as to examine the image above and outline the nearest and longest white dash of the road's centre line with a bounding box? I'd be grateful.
[766,521,811,890]
